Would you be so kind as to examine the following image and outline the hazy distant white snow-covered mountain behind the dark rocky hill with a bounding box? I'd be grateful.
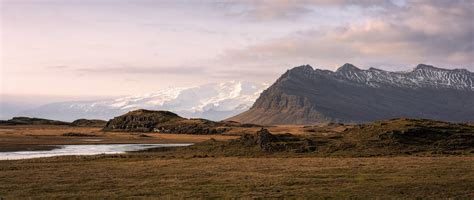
[20,81,268,121]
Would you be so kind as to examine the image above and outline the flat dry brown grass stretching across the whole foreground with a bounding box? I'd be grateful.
[0,154,474,199]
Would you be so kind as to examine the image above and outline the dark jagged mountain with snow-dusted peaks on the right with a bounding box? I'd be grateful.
[229,64,474,124]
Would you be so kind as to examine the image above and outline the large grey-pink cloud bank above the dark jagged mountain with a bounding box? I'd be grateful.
[216,1,474,70]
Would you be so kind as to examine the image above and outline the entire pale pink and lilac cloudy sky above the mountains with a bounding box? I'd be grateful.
[0,0,474,97]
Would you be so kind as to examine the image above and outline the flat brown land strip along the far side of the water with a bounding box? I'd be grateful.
[0,126,238,152]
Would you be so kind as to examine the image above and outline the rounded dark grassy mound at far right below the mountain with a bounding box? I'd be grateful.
[340,118,474,153]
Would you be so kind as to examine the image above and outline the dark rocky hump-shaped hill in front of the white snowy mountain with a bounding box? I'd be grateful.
[104,109,231,134]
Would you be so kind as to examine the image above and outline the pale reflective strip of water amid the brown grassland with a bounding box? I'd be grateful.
[0,144,192,160]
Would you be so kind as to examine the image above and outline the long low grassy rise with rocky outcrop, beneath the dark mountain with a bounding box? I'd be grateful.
[160,118,474,156]
